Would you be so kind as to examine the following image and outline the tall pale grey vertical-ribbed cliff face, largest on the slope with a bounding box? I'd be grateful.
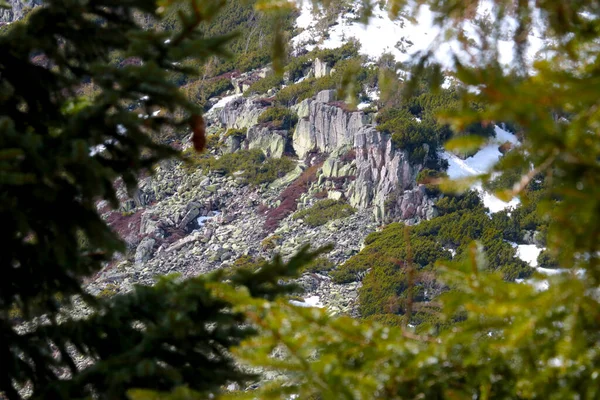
[293,90,435,222]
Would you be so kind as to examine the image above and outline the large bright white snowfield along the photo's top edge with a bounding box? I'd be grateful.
[292,0,543,69]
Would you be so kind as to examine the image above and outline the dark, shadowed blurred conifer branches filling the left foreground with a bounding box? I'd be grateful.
[0,0,314,399]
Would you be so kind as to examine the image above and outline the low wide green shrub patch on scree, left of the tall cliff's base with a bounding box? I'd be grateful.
[197,149,296,185]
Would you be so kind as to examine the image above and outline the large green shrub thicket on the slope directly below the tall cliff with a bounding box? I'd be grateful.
[330,192,546,320]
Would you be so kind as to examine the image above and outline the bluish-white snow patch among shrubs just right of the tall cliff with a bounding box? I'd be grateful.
[441,126,519,213]
